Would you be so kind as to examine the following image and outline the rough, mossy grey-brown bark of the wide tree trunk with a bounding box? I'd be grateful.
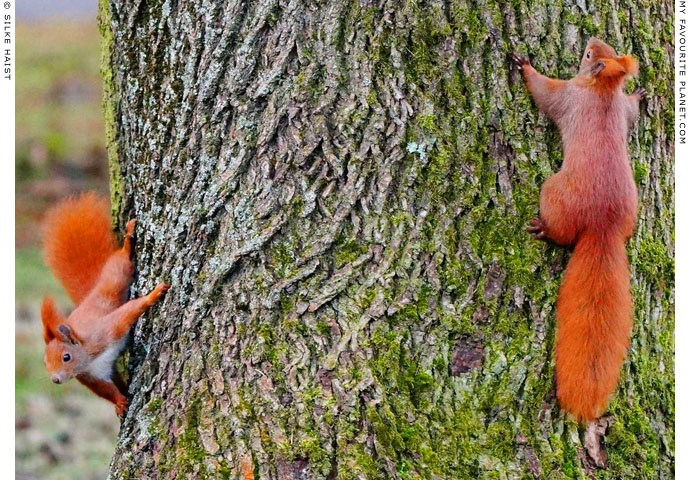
[101,0,674,479]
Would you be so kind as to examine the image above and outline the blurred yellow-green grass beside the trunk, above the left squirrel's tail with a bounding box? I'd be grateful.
[16,19,105,181]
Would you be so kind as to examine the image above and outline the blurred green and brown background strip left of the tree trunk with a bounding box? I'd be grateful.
[15,0,119,480]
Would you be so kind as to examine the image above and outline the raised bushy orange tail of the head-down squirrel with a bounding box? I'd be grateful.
[43,192,117,304]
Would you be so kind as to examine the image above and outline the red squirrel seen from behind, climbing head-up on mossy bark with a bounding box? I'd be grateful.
[513,38,646,421]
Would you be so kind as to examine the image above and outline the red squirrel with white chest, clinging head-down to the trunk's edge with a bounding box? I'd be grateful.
[41,193,170,417]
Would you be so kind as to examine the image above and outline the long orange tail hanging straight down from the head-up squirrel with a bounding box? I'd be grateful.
[556,234,633,421]
